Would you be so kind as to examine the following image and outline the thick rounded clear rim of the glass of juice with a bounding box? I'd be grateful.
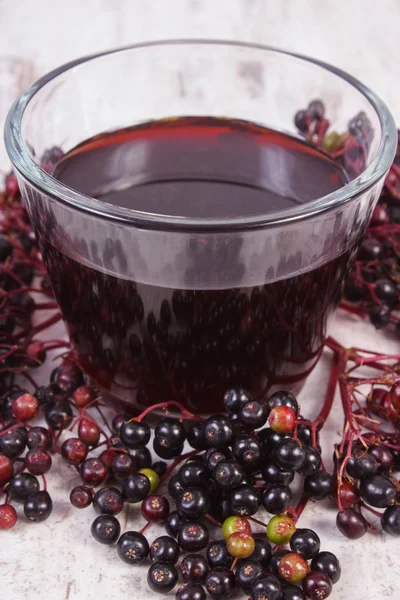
[4,39,397,231]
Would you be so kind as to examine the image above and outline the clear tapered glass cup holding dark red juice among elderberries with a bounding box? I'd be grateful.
[5,40,397,413]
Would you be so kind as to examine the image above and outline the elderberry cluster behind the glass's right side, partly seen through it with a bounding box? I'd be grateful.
[294,100,400,334]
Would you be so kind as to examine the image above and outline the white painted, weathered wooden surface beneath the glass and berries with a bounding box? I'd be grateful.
[0,0,400,600]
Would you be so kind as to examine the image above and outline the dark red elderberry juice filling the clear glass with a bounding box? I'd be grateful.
[39,117,355,413]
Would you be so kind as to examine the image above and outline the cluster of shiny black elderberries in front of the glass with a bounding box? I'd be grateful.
[65,388,340,600]
